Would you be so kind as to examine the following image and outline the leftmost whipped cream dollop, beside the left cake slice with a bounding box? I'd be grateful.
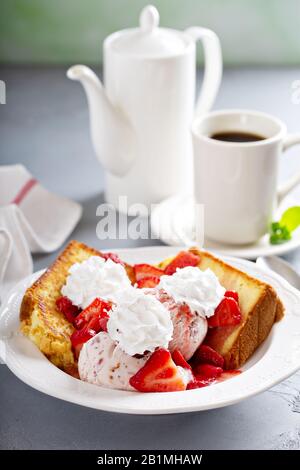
[61,256,131,308]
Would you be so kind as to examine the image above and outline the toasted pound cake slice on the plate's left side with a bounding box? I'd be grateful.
[20,241,101,374]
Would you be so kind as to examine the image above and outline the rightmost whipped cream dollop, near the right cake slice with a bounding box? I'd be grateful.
[157,266,225,317]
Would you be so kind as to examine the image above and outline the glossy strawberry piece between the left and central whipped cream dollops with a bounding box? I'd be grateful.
[74,298,112,333]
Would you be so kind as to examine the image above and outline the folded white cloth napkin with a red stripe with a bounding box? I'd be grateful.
[0,165,82,300]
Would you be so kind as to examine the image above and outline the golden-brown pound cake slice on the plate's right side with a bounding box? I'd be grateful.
[190,248,284,369]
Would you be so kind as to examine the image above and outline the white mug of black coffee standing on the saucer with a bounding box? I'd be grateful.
[192,109,300,244]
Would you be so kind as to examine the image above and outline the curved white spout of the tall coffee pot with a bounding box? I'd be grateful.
[67,65,135,177]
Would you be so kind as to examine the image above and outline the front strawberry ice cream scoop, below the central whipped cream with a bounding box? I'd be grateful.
[78,331,148,390]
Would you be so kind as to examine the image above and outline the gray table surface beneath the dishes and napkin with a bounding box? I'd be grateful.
[0,67,300,450]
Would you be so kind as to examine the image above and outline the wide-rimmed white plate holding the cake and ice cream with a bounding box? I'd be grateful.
[0,247,300,414]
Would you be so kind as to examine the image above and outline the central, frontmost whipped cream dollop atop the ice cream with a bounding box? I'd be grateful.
[107,287,173,356]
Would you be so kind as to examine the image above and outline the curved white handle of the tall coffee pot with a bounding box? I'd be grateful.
[185,26,223,117]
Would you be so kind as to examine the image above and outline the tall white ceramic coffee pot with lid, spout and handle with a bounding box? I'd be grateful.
[67,5,222,208]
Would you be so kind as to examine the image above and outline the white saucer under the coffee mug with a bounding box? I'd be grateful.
[151,195,300,259]
